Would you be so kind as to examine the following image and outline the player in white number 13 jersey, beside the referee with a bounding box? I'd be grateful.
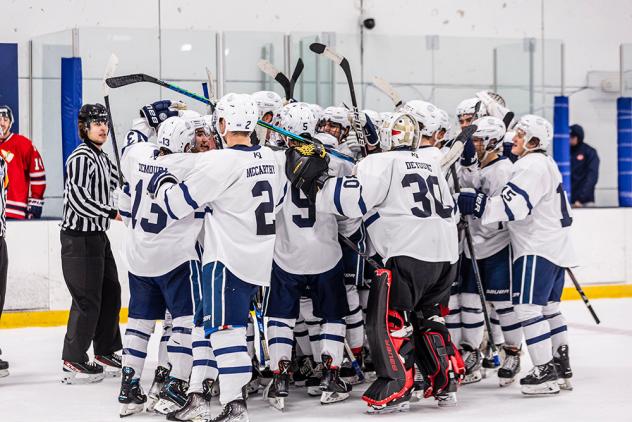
[119,117,204,416]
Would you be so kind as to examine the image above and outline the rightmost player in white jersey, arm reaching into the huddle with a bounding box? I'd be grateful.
[458,115,576,395]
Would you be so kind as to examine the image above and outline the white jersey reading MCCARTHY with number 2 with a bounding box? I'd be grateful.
[157,145,287,286]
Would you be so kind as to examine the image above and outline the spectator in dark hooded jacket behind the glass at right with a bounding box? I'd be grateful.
[570,125,599,207]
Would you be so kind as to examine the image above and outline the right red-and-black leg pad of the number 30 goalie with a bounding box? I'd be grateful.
[415,320,465,397]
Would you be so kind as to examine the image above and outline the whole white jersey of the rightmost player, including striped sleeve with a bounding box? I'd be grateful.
[482,152,576,267]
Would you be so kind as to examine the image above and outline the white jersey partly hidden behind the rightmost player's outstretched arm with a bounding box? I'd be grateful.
[459,157,513,259]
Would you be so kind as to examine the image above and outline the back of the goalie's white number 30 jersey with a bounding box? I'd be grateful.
[358,150,458,262]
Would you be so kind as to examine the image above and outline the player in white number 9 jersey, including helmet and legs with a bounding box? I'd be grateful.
[264,103,351,409]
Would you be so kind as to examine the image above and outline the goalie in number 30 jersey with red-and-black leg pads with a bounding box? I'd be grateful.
[288,113,460,412]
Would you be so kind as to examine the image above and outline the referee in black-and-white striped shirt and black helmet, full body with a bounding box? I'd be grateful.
[60,104,122,384]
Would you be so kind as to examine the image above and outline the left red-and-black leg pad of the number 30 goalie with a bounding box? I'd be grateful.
[362,270,414,408]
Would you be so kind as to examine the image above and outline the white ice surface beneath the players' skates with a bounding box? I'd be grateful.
[0,299,632,422]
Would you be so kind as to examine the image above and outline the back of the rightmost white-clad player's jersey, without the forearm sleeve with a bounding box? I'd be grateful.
[504,153,575,267]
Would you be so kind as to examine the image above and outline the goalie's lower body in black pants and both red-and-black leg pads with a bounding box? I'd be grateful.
[362,264,465,413]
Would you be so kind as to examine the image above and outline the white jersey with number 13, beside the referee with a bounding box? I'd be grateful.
[119,142,204,277]
